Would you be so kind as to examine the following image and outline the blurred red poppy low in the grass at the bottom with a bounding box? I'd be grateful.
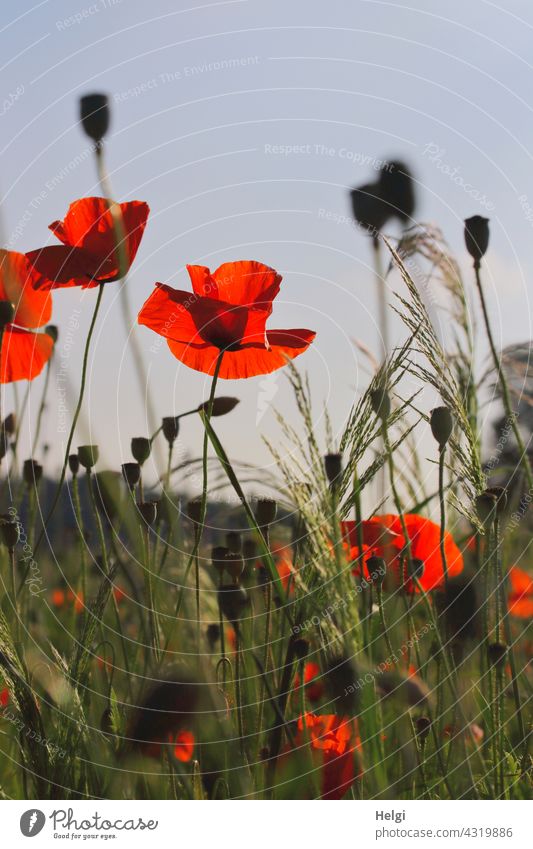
[286,713,362,799]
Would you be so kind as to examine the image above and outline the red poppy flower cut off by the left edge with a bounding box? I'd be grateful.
[0,250,54,383]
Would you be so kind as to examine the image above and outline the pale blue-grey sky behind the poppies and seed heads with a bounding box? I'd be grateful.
[0,0,533,490]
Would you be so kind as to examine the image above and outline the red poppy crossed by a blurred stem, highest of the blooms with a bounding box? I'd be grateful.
[26,197,150,289]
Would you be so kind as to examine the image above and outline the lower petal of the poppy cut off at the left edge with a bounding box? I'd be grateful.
[0,325,54,383]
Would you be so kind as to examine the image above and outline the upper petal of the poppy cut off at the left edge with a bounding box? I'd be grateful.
[0,250,52,327]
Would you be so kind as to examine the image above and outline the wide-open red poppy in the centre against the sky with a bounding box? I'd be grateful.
[138,260,315,380]
